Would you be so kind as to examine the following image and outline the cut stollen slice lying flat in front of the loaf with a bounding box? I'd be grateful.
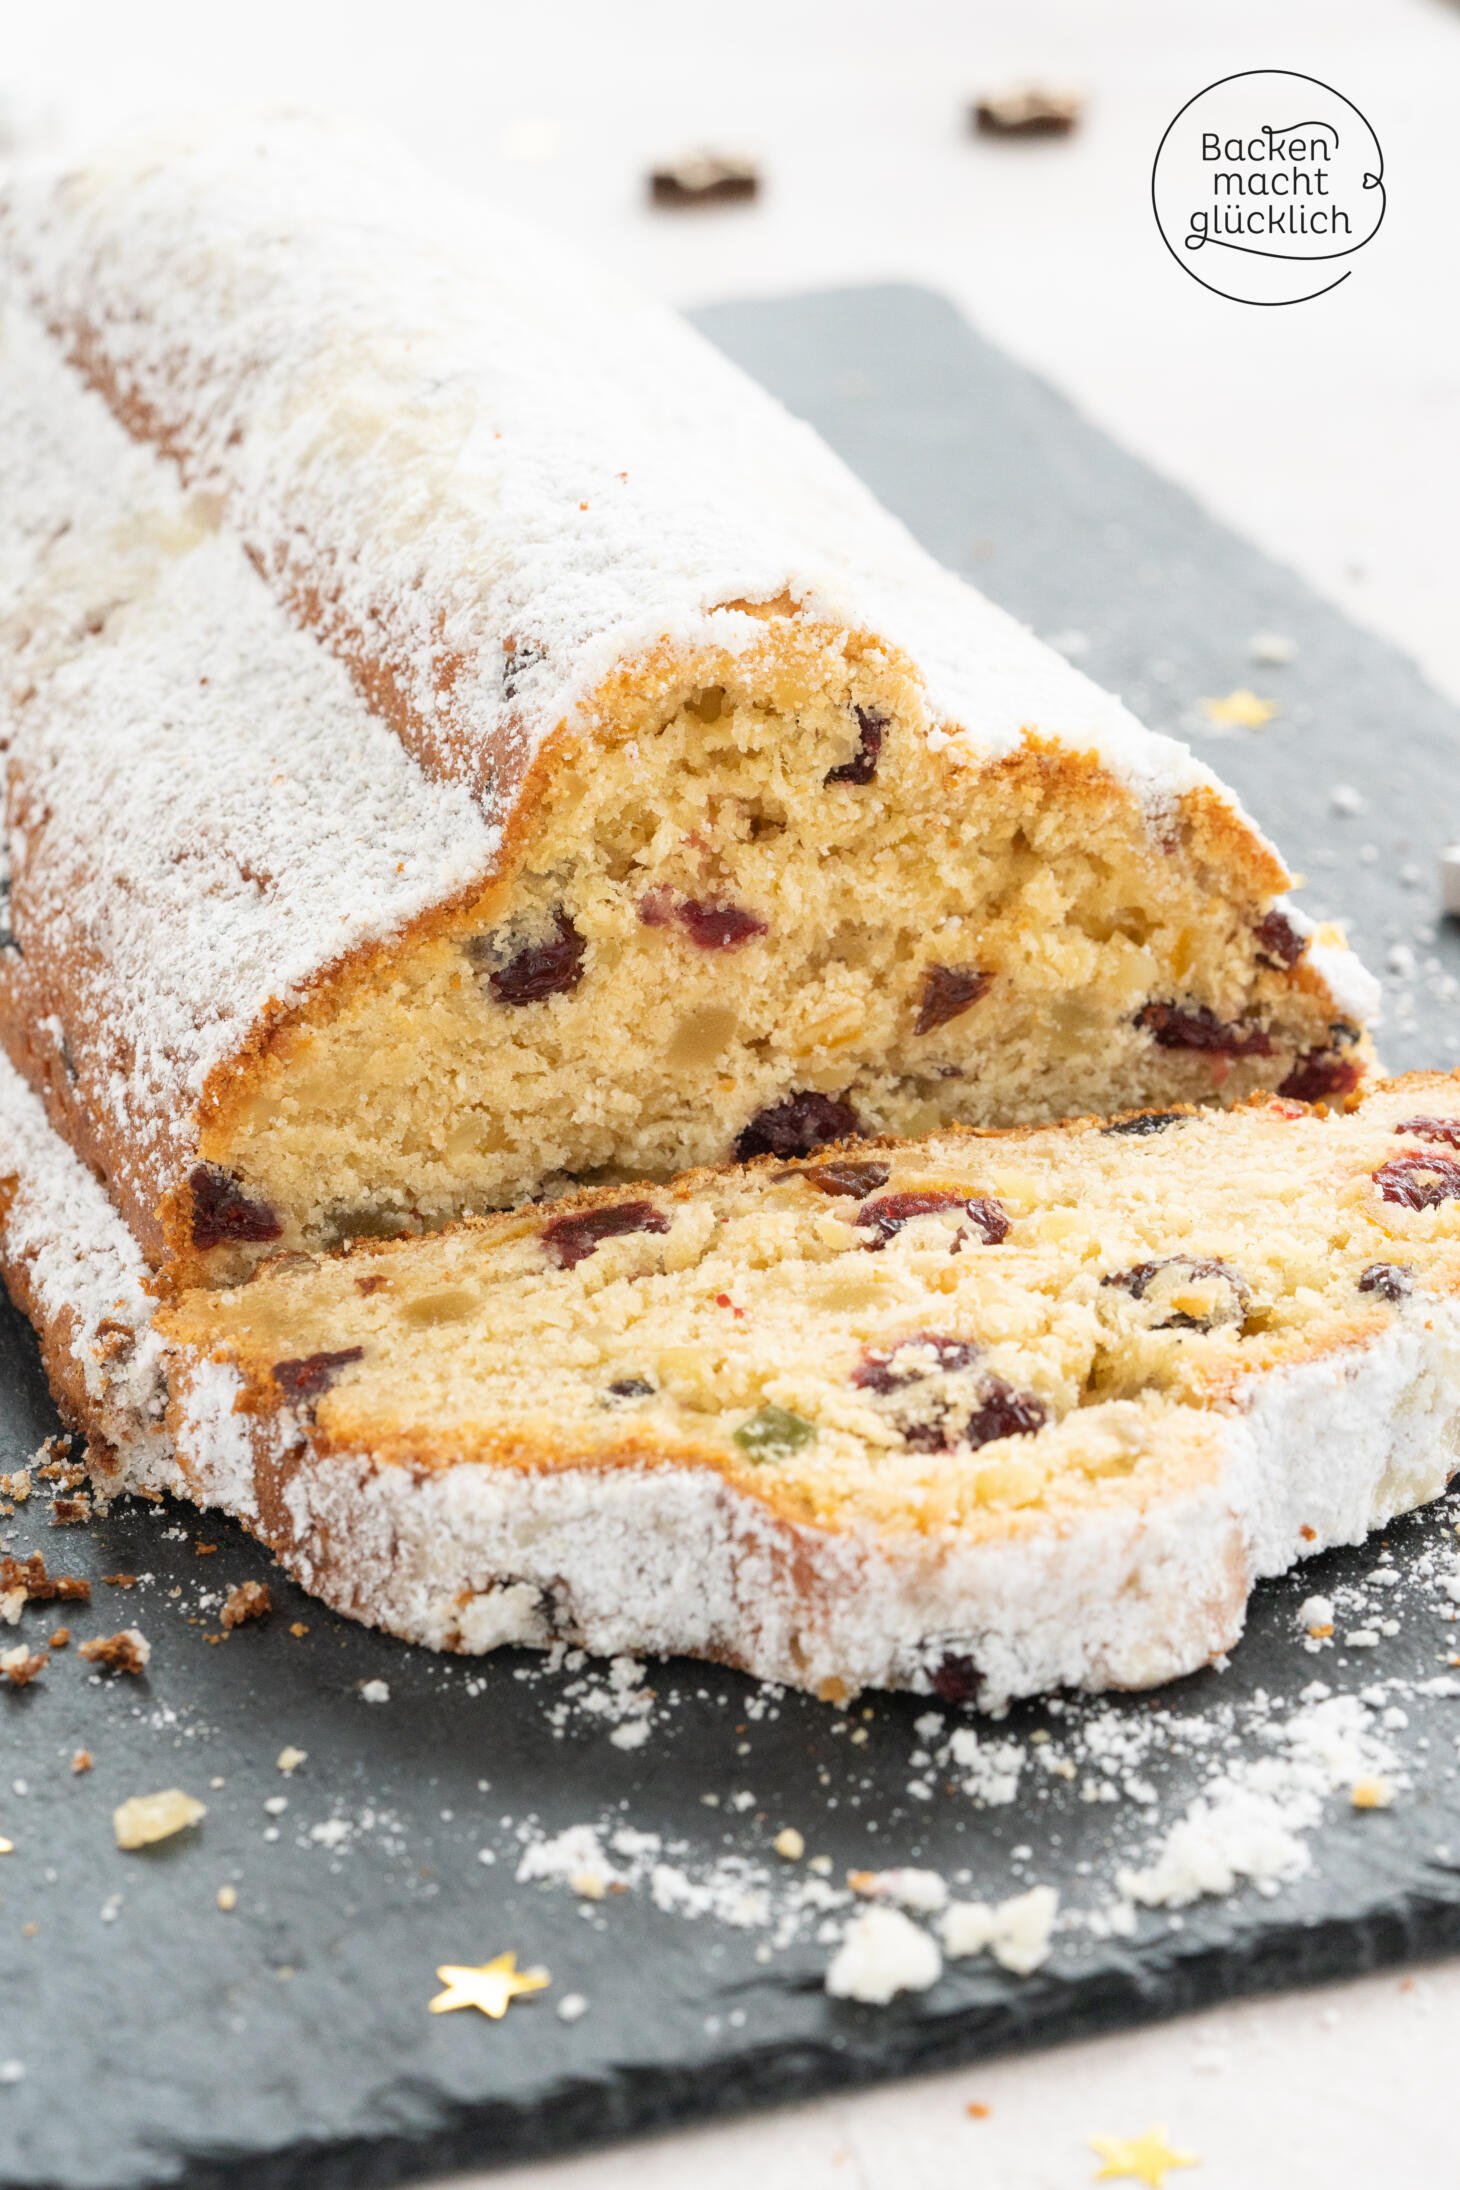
[142,1073,1460,1702]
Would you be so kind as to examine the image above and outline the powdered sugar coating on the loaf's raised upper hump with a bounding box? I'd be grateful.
[2,118,1243,827]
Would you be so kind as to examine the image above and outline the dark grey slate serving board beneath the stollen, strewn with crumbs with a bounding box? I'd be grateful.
[0,289,1460,2190]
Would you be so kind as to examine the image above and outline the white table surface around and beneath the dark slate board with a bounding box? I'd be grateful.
[11,0,1460,2190]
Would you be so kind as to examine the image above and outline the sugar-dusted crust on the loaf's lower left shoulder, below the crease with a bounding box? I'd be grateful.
[0,309,499,1226]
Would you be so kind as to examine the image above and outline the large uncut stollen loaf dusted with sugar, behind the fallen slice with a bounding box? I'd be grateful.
[0,123,1372,1283]
